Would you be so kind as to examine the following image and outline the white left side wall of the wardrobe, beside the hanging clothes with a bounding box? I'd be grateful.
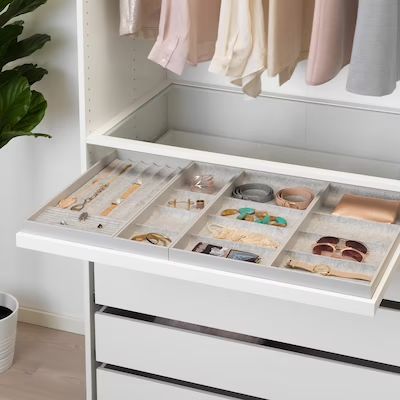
[78,0,166,133]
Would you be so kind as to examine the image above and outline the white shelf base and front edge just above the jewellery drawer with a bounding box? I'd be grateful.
[87,129,400,181]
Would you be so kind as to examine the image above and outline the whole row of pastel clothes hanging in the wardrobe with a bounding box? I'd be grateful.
[120,0,400,97]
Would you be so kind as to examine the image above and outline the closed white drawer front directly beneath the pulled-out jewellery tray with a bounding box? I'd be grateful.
[95,264,400,366]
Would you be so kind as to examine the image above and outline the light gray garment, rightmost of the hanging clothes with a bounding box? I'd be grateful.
[347,0,400,96]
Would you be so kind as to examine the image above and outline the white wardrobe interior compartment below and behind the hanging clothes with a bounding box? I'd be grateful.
[80,0,400,178]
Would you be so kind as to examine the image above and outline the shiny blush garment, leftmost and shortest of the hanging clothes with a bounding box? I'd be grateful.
[119,0,161,38]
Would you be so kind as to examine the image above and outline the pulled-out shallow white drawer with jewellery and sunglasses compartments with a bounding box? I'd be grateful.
[17,151,400,316]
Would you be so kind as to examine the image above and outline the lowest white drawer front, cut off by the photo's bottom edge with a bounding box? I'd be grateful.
[97,368,232,400]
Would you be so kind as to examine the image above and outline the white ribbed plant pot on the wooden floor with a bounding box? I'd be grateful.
[0,292,19,374]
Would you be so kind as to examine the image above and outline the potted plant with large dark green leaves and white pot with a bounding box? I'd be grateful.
[0,0,50,373]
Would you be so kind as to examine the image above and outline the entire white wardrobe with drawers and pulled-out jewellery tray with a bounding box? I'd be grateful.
[17,0,400,400]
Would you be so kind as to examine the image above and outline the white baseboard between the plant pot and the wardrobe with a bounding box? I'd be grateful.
[18,307,85,335]
